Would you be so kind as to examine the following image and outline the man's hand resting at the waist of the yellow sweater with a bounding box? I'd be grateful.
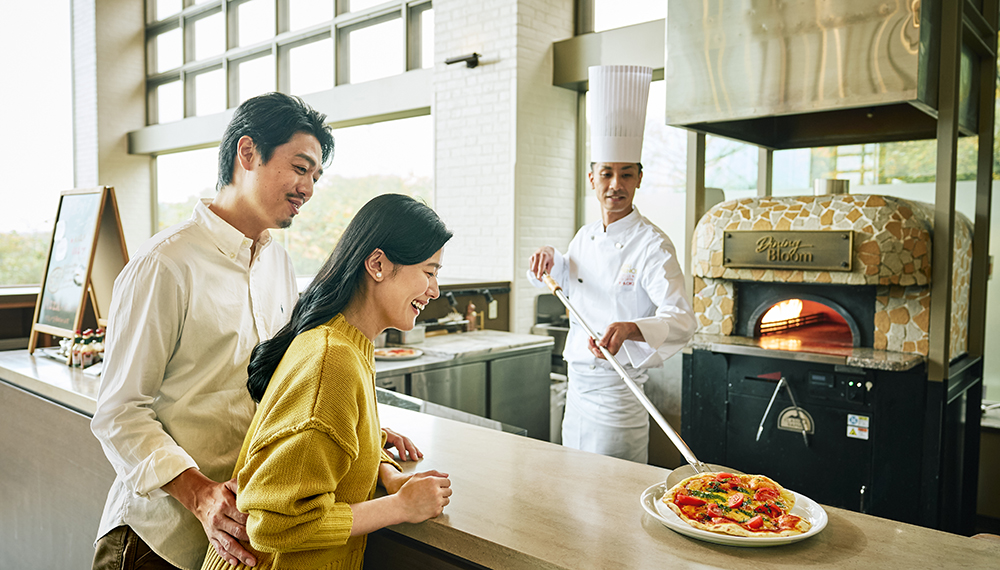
[163,468,257,566]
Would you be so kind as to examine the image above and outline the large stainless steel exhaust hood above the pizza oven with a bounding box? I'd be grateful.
[665,0,980,149]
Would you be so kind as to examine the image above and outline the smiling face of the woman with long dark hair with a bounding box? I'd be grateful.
[377,249,442,331]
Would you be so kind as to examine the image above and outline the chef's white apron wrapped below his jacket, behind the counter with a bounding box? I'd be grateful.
[562,364,649,463]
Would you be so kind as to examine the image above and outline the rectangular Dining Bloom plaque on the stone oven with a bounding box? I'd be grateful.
[722,230,854,271]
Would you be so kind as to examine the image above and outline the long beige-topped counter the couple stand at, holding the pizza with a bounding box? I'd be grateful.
[0,351,1000,570]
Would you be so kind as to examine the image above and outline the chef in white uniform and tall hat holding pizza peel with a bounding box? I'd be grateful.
[528,65,696,463]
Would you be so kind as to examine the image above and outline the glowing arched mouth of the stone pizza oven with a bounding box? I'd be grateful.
[745,292,861,349]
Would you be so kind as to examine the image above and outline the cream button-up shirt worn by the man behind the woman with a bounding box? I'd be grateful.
[91,203,298,570]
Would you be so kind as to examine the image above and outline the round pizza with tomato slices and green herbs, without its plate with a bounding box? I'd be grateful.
[662,473,812,537]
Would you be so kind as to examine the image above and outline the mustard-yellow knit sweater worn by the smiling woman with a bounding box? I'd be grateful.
[202,315,399,570]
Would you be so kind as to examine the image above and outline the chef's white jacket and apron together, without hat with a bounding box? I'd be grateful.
[528,208,696,463]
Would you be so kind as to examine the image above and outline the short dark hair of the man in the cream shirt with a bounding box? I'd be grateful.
[216,93,333,190]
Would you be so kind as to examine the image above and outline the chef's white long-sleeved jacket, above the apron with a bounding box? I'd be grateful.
[528,207,697,377]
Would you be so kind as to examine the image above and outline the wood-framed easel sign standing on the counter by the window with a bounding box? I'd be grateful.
[28,186,128,362]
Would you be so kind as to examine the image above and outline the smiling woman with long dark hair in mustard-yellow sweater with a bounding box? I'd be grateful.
[202,194,451,570]
